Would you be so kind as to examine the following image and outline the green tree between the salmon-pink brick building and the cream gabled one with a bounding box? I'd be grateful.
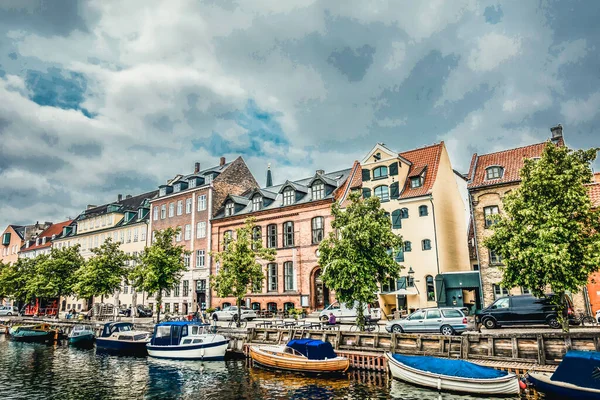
[319,193,402,329]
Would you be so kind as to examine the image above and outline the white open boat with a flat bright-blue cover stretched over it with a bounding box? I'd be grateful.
[385,353,520,396]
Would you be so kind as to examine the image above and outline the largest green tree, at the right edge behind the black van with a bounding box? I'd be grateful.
[484,143,600,331]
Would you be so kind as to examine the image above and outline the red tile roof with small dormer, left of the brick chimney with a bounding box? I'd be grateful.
[468,142,548,189]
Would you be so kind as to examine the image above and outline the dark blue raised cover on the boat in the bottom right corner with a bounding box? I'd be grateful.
[550,350,600,389]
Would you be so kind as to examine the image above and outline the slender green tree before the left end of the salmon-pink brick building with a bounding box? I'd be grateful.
[211,218,275,326]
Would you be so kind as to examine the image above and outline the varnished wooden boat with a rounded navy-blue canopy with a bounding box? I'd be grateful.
[250,339,350,373]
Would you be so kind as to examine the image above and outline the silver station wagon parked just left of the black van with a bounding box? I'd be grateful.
[385,307,471,336]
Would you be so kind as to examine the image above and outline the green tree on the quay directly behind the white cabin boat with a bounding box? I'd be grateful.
[129,228,190,323]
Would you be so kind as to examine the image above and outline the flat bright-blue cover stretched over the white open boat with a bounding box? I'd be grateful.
[392,354,508,379]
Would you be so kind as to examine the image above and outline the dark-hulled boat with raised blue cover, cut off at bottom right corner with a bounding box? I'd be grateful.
[527,350,600,399]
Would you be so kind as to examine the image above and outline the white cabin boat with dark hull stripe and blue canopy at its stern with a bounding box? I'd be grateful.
[146,321,229,361]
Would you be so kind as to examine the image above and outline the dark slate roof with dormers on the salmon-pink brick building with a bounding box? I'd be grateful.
[215,168,352,219]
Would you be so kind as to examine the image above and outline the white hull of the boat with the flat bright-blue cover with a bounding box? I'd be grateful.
[385,353,520,395]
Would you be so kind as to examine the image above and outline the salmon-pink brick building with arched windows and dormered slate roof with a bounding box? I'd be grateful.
[211,162,360,311]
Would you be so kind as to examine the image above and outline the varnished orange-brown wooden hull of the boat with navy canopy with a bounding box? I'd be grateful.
[250,346,350,373]
